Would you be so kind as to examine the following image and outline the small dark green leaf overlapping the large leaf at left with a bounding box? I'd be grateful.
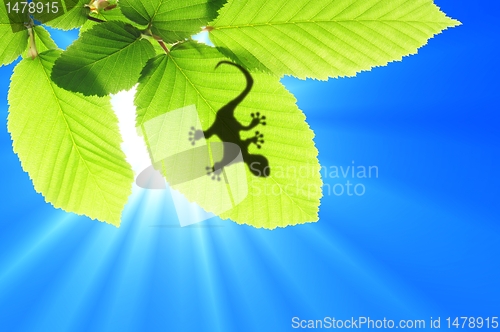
[52,22,155,96]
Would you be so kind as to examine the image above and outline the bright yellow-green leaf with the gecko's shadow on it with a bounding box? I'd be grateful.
[135,42,322,229]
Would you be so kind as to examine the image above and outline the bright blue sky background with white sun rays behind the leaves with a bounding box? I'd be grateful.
[0,0,500,331]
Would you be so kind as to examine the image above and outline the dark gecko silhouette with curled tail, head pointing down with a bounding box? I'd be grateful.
[189,61,271,181]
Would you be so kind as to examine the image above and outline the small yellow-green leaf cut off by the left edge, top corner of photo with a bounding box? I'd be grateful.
[0,4,29,66]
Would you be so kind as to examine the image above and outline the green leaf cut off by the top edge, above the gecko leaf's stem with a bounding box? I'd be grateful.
[120,0,224,43]
